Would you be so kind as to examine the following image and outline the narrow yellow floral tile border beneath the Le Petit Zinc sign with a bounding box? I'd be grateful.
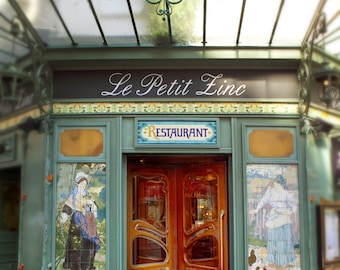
[53,102,298,114]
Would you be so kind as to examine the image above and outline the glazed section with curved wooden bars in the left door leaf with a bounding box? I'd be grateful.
[132,175,167,265]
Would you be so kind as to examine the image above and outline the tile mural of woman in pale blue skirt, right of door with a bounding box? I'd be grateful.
[247,164,301,270]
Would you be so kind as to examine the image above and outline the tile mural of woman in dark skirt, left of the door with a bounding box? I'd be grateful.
[55,163,106,270]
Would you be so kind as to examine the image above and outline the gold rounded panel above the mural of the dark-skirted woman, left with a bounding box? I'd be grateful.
[60,129,104,157]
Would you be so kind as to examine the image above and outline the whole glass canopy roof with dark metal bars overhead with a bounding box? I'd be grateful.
[0,0,340,69]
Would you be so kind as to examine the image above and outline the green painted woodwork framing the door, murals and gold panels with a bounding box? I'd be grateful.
[1,111,334,270]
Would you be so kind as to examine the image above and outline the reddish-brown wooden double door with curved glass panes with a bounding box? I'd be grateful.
[127,156,228,270]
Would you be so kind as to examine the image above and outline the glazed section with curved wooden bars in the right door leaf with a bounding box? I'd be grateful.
[184,173,218,267]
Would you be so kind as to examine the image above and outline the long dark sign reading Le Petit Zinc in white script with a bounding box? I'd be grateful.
[53,70,298,101]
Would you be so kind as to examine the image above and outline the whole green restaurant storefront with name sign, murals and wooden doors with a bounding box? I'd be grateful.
[0,47,335,270]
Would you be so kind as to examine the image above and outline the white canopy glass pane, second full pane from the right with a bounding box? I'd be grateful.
[239,0,281,46]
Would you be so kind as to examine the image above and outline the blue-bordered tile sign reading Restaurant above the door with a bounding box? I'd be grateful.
[136,119,218,147]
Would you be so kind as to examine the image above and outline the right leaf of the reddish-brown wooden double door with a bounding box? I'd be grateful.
[177,162,227,270]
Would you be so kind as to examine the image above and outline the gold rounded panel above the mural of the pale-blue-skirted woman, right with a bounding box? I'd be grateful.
[249,129,294,158]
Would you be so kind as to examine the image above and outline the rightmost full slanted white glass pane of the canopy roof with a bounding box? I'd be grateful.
[272,0,319,46]
